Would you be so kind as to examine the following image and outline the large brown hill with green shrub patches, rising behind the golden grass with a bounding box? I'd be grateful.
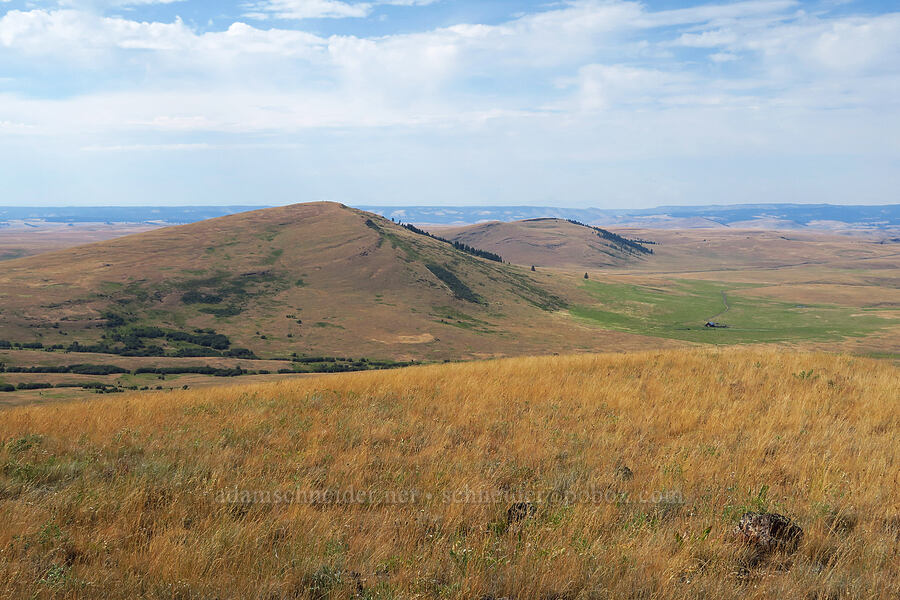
[0,203,660,359]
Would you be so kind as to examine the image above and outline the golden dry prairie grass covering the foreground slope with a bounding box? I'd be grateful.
[0,349,900,599]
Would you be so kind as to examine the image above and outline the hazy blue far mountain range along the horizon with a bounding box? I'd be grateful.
[0,204,900,231]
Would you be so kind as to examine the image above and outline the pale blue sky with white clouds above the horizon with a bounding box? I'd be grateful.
[0,0,900,208]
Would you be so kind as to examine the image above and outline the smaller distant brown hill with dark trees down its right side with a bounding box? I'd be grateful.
[431,219,650,269]
